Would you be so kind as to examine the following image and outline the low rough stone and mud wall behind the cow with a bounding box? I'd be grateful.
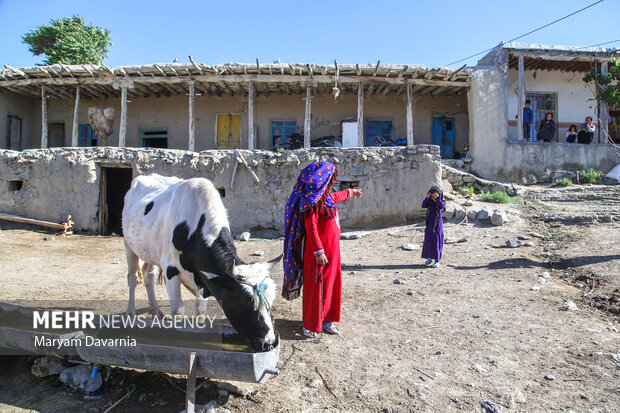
[0,145,441,232]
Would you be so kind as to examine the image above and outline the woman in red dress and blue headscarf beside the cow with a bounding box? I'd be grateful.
[282,162,362,338]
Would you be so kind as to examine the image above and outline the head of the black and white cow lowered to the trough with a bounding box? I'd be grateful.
[202,256,282,351]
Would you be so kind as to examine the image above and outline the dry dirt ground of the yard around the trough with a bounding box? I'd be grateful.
[0,185,620,413]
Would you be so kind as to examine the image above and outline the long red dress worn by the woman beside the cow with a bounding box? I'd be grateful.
[303,189,351,333]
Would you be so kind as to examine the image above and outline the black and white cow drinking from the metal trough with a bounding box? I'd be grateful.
[123,174,280,351]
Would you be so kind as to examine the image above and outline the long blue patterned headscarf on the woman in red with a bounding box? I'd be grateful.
[282,162,338,300]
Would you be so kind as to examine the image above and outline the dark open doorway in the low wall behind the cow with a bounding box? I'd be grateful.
[99,165,133,235]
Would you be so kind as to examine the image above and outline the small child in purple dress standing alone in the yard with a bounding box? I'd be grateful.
[422,186,446,268]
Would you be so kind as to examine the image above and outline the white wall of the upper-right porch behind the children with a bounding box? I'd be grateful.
[506,70,597,138]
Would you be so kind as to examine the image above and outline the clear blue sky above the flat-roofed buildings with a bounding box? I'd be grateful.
[0,0,620,67]
